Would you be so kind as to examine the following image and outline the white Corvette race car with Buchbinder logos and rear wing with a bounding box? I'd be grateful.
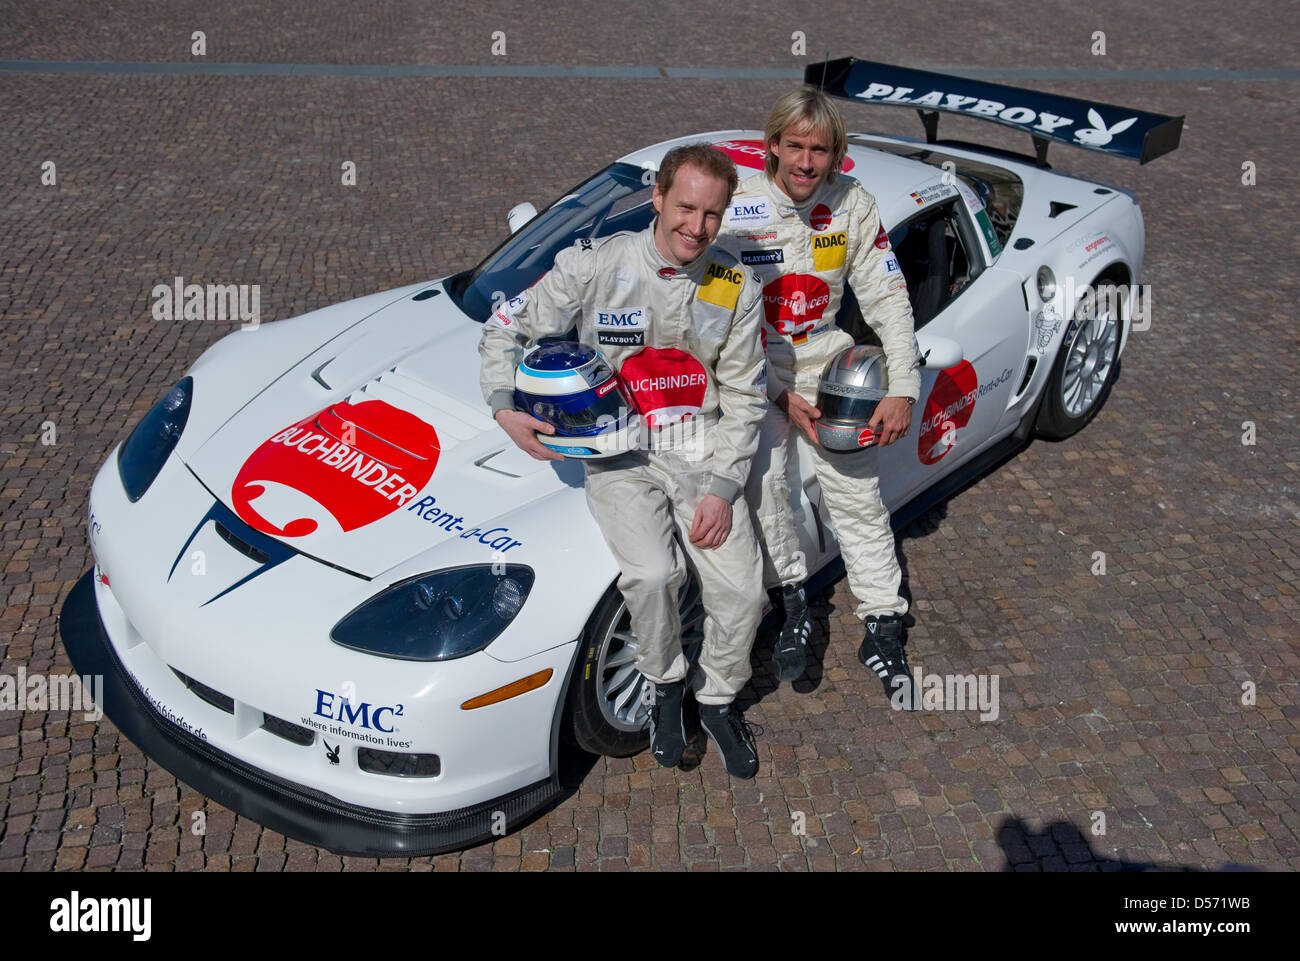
[61,60,1182,856]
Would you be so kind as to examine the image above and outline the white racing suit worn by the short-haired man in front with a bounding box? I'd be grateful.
[478,225,767,704]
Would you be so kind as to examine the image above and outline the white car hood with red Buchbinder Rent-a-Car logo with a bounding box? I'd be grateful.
[187,282,581,577]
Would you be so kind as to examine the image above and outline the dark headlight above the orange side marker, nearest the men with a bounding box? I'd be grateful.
[330,564,533,661]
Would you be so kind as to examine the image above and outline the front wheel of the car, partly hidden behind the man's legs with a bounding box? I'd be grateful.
[568,576,705,757]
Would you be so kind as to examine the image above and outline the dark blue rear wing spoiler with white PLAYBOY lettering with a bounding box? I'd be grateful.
[803,57,1183,166]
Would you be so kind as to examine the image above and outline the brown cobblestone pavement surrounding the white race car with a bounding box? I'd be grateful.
[0,0,1300,871]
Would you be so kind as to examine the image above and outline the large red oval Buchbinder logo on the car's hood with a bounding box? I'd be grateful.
[230,401,439,537]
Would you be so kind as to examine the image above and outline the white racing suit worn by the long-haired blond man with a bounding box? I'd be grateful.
[718,172,920,619]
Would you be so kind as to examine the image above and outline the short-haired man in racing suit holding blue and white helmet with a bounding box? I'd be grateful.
[478,144,767,778]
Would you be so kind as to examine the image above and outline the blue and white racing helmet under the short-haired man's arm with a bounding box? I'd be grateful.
[515,341,641,458]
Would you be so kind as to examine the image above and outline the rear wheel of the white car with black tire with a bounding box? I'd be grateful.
[1034,281,1125,441]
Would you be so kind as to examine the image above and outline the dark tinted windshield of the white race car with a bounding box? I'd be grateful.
[447,164,654,324]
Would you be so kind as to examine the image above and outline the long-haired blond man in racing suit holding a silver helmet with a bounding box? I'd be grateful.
[719,87,920,704]
